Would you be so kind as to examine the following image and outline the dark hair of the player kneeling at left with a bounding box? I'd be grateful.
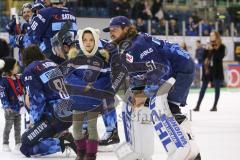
[23,45,45,66]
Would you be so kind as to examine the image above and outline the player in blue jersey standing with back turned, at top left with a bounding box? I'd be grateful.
[16,0,77,64]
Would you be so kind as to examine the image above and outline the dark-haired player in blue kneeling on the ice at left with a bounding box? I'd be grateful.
[20,45,76,157]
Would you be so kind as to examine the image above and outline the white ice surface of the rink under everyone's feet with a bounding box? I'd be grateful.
[0,91,240,160]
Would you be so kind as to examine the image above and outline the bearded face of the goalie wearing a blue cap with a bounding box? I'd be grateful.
[109,27,127,43]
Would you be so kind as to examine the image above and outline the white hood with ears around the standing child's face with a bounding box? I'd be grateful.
[78,27,100,57]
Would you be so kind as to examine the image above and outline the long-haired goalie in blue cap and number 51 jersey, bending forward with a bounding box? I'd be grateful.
[103,16,201,160]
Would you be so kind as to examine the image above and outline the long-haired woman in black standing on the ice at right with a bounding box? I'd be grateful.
[193,31,226,111]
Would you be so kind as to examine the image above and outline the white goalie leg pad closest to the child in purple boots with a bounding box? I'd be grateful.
[114,104,154,160]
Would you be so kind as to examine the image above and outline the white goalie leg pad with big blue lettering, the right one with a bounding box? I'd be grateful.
[149,78,199,160]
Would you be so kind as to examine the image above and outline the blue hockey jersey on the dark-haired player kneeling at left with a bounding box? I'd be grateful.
[22,61,61,123]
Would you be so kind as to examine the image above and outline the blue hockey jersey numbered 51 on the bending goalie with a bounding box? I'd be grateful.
[122,33,195,87]
